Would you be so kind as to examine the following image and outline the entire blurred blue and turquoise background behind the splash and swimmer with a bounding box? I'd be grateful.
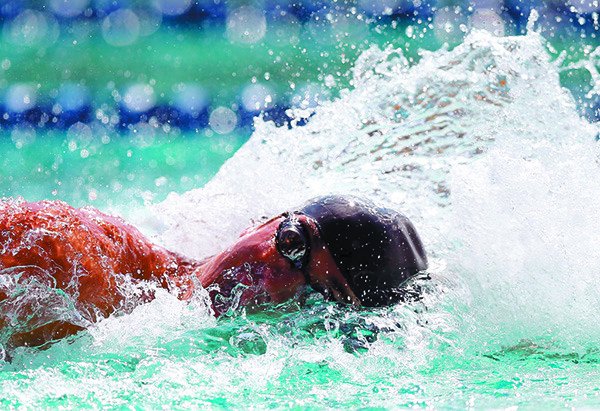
[0,0,600,206]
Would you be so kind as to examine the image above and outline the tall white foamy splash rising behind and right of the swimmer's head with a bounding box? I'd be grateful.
[148,31,600,354]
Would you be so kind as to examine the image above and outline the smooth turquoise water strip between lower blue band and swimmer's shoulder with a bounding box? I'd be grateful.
[0,129,247,209]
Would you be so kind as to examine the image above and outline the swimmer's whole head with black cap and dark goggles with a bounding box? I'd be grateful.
[200,196,427,314]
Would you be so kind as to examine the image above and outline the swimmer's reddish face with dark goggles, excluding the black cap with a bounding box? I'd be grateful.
[200,214,358,314]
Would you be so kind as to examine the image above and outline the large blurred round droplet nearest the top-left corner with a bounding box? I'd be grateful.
[2,9,58,47]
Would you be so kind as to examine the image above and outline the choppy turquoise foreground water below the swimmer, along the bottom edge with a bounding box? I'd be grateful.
[0,294,600,409]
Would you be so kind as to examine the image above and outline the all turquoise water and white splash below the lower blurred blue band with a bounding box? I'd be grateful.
[0,14,600,409]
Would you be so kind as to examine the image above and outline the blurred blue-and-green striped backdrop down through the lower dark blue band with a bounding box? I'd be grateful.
[0,0,600,134]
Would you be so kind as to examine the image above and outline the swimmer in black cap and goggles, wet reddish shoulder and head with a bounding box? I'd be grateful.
[0,196,427,346]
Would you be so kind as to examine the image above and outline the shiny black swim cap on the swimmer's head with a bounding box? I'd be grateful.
[298,196,427,307]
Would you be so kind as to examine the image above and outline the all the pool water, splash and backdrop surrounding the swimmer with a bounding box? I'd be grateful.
[0,0,600,409]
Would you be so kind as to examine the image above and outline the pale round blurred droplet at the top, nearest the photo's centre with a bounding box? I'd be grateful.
[227,6,267,44]
